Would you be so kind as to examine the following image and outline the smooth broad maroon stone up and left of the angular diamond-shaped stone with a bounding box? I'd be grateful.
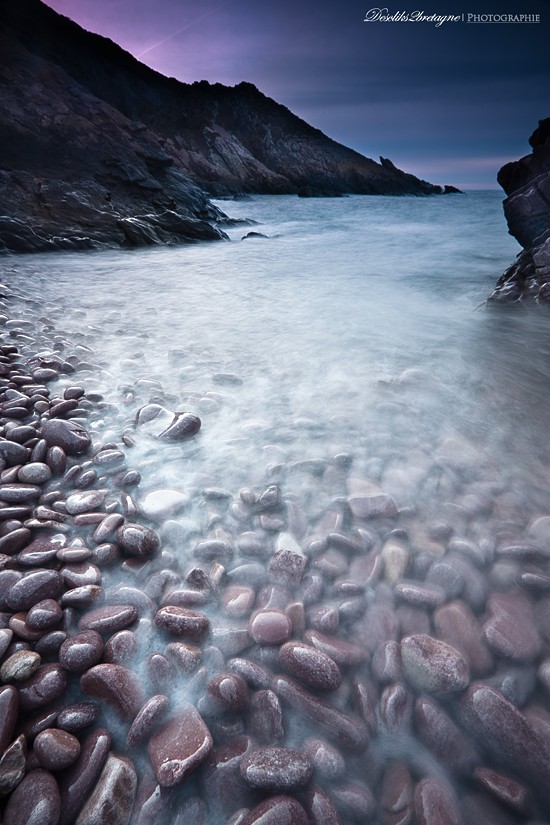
[80,664,144,720]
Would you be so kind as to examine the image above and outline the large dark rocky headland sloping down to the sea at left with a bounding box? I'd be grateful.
[0,0,452,251]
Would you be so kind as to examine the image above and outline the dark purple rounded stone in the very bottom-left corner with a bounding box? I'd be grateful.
[2,769,61,825]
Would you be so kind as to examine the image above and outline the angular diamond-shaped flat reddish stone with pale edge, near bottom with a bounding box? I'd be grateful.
[147,702,213,788]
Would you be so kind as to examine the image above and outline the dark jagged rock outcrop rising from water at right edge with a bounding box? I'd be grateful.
[489,118,550,304]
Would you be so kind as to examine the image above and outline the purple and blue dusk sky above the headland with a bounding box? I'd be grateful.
[42,0,550,188]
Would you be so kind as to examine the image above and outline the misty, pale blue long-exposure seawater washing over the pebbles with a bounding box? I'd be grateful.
[1,192,550,825]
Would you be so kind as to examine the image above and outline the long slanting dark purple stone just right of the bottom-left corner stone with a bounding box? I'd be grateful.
[59,728,111,825]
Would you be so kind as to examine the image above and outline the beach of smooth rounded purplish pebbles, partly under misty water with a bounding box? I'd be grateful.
[0,280,550,825]
